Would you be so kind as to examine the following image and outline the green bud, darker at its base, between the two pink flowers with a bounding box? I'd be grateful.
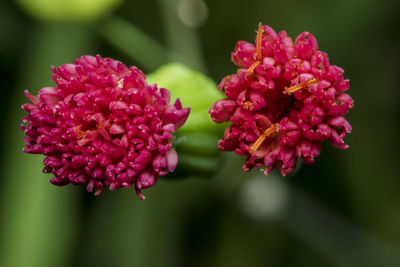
[147,63,224,177]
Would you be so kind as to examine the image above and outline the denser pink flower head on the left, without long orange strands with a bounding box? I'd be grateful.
[21,56,190,199]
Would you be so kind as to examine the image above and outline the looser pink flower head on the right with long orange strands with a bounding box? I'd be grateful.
[209,24,353,175]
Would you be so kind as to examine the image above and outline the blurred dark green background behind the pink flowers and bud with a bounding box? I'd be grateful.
[0,0,400,267]
